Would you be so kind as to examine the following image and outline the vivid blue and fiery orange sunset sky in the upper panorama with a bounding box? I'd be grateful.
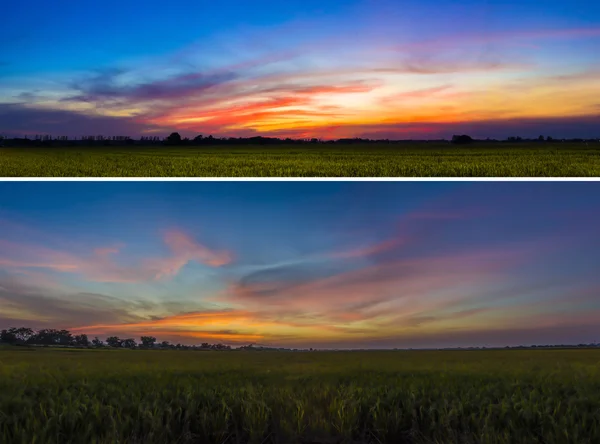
[0,0,600,139]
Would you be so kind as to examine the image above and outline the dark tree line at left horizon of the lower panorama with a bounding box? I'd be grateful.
[0,327,231,351]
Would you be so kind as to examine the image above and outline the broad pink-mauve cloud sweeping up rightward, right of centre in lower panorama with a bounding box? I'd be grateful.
[224,249,529,321]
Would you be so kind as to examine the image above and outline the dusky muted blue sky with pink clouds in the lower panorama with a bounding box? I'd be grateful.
[0,182,600,349]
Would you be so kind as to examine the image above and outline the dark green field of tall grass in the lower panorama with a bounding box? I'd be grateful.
[0,348,600,444]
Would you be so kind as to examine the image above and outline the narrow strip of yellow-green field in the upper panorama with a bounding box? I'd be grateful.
[0,143,600,177]
